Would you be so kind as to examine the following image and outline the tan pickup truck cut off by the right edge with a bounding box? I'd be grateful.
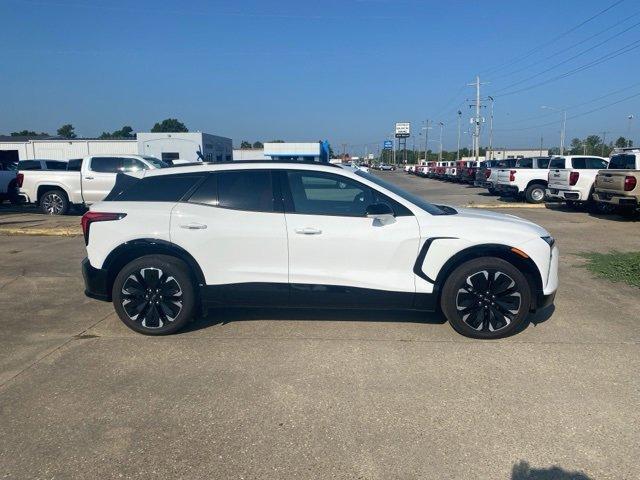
[593,149,640,215]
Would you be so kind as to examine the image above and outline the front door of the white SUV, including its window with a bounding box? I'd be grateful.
[282,170,420,307]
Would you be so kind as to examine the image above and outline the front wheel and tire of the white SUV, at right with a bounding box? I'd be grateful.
[440,257,531,339]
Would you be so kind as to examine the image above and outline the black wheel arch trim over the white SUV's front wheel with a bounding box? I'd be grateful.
[434,243,543,312]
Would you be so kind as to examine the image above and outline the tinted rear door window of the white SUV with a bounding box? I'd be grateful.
[189,170,276,212]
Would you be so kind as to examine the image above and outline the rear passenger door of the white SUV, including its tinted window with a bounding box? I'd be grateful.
[171,169,288,305]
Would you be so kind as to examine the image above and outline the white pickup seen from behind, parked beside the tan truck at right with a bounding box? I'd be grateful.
[546,155,609,206]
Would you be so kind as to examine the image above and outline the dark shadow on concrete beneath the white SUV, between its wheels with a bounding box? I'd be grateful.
[181,307,447,333]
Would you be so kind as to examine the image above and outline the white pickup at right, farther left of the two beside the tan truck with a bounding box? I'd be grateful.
[495,157,550,203]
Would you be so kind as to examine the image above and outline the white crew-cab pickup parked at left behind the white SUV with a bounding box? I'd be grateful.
[18,155,169,215]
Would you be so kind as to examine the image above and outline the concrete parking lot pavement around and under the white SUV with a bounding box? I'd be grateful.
[0,172,640,480]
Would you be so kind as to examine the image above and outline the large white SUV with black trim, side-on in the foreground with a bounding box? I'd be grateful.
[82,162,558,338]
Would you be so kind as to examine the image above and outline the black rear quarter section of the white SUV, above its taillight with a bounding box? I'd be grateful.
[108,174,202,202]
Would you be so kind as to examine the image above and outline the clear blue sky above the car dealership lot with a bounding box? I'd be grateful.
[0,0,640,151]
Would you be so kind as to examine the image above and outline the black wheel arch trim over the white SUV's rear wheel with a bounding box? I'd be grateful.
[102,238,206,293]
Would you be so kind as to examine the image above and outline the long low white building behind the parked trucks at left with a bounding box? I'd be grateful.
[0,132,233,163]
